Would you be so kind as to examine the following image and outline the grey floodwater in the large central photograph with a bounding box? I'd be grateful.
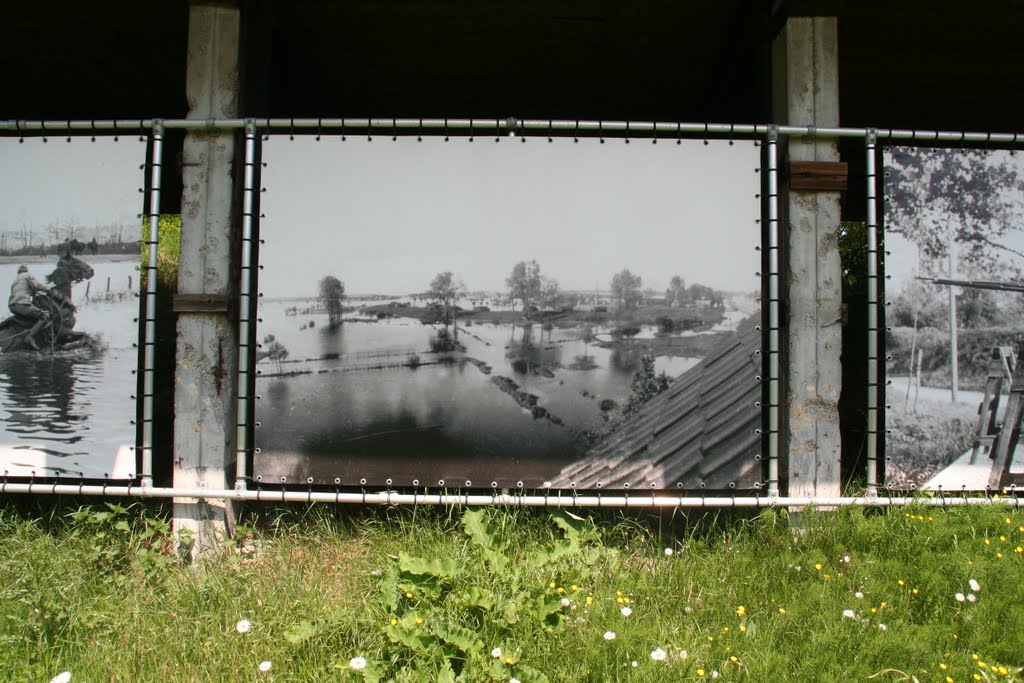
[254,300,699,487]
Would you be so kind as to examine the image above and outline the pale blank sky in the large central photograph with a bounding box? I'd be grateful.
[259,135,761,298]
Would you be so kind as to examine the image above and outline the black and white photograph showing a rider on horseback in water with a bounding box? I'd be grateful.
[0,136,146,480]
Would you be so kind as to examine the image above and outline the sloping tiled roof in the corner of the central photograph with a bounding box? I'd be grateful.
[552,314,762,488]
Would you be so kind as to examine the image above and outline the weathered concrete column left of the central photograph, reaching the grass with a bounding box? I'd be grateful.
[174,2,241,556]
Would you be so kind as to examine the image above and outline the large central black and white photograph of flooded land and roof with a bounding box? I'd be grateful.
[254,135,763,488]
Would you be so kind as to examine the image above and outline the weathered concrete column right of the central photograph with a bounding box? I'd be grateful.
[772,16,843,496]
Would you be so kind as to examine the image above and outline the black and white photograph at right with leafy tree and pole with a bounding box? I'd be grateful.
[883,147,1024,490]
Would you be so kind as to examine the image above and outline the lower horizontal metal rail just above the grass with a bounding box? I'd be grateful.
[0,482,1021,509]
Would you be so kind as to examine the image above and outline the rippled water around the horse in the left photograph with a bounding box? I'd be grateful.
[0,255,139,479]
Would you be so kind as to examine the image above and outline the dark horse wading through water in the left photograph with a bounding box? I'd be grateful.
[0,250,93,352]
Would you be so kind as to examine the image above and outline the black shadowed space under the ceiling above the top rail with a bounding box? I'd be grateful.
[0,0,1024,131]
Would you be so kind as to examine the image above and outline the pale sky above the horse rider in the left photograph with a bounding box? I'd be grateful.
[0,135,145,239]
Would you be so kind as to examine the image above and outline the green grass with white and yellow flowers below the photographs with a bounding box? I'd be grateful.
[0,501,1024,683]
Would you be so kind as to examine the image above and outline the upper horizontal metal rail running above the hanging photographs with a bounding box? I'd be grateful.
[0,117,1024,144]
